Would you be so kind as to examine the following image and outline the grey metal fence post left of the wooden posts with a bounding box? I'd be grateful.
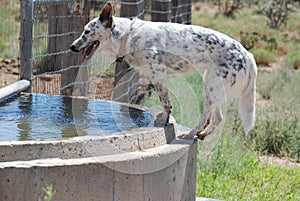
[20,0,34,92]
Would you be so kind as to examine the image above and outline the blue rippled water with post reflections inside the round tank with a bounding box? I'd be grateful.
[0,94,153,141]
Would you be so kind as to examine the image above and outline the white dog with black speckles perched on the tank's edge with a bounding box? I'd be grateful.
[70,3,257,139]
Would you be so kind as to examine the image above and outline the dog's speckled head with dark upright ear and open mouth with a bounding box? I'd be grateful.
[70,3,114,62]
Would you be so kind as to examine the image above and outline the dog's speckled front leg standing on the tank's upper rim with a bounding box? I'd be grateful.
[154,82,172,127]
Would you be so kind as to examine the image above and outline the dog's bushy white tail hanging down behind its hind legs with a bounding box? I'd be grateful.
[239,55,257,135]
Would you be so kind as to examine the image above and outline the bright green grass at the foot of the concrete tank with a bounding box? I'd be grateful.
[197,141,300,201]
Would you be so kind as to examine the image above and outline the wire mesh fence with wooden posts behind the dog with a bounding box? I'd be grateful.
[20,0,192,102]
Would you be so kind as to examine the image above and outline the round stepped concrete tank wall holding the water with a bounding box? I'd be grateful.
[0,97,197,201]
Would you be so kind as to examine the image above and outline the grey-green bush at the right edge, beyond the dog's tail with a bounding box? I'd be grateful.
[247,107,300,161]
